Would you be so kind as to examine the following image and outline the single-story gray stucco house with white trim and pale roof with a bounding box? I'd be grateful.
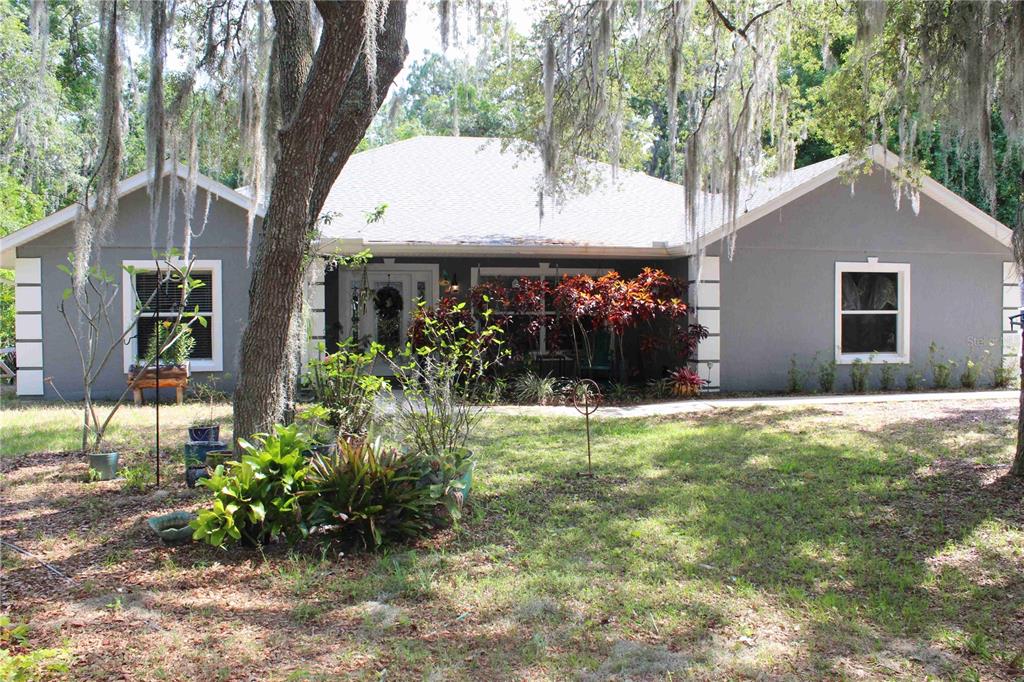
[0,137,1021,397]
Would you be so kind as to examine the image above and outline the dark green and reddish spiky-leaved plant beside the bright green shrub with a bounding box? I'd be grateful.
[303,438,437,548]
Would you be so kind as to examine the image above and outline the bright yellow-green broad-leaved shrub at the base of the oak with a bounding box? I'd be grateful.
[190,425,312,547]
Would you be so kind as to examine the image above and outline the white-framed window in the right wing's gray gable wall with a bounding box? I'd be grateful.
[836,259,910,364]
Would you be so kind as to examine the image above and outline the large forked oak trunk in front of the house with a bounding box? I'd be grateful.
[234,0,409,438]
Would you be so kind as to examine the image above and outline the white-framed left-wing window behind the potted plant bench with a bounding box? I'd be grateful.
[122,260,223,372]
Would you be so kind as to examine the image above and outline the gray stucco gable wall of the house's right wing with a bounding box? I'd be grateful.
[708,168,1016,391]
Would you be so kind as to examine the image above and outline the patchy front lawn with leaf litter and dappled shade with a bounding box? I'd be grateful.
[0,401,1024,680]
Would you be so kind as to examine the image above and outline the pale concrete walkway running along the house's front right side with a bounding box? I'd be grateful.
[485,389,1020,418]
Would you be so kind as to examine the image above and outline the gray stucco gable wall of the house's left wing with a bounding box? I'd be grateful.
[17,184,259,399]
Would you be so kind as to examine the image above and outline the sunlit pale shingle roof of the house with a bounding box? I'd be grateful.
[323,136,845,249]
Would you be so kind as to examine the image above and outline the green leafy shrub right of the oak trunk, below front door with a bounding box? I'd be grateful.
[303,338,390,437]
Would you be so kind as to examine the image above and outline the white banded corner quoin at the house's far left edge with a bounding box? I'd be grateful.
[14,258,43,395]
